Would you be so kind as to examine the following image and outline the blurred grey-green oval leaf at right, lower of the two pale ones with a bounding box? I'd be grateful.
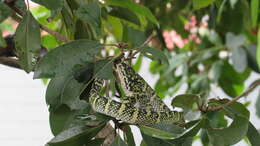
[231,47,247,73]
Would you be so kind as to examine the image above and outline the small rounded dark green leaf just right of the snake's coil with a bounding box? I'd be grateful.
[172,94,199,109]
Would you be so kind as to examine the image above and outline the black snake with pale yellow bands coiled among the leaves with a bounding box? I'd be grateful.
[89,57,184,125]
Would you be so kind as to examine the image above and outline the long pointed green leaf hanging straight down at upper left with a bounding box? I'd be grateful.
[15,11,41,72]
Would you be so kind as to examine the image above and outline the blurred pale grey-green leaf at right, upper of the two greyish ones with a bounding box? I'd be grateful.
[226,32,246,49]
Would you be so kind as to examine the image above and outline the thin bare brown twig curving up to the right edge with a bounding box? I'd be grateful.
[203,80,260,112]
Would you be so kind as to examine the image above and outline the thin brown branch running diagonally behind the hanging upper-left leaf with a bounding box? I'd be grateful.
[5,0,70,42]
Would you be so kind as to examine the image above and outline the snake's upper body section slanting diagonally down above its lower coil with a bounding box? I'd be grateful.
[114,58,170,111]
